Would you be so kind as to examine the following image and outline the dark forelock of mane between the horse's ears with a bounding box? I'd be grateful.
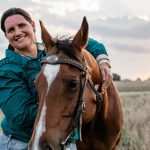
[54,36,78,60]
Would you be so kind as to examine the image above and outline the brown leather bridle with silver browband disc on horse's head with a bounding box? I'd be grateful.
[41,55,103,150]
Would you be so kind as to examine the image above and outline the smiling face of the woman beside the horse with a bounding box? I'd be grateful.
[4,14,35,50]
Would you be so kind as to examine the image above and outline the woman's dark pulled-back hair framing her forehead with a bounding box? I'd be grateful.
[1,8,32,33]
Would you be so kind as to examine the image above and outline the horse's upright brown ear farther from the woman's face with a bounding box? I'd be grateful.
[72,17,89,51]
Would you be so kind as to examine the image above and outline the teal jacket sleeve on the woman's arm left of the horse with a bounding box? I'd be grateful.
[0,71,38,127]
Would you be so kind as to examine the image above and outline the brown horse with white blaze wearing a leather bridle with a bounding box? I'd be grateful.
[29,17,123,150]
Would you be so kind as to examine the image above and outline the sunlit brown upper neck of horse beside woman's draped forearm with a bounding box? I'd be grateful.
[83,50,102,85]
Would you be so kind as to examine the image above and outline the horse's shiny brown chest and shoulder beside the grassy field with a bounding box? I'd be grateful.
[82,83,123,149]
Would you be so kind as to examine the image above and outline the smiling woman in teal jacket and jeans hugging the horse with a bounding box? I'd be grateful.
[0,8,112,150]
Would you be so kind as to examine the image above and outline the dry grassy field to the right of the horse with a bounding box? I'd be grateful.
[0,80,150,150]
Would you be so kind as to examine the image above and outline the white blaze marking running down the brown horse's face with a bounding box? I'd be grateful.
[33,64,60,150]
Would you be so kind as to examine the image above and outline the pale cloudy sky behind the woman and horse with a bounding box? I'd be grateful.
[0,0,150,80]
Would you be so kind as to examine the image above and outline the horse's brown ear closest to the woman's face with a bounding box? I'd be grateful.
[40,20,55,50]
